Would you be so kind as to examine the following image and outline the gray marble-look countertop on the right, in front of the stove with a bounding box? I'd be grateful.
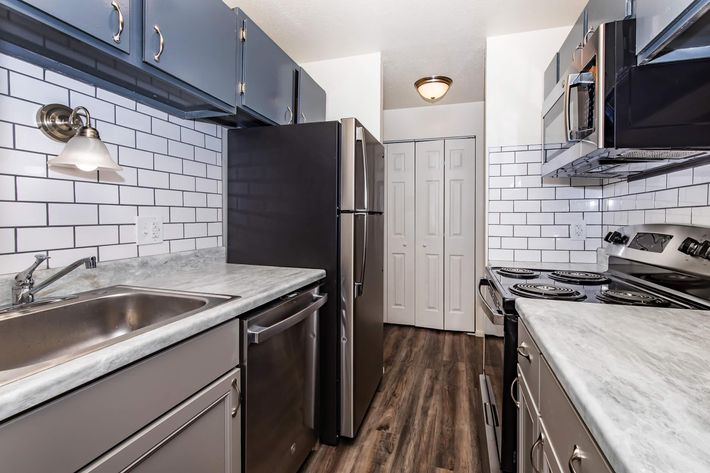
[516,298,710,473]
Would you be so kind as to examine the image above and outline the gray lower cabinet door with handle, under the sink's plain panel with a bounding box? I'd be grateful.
[81,369,241,473]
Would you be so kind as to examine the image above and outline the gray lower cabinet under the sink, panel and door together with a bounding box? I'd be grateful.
[0,320,241,473]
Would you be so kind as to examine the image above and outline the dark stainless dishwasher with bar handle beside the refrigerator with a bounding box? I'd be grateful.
[242,287,328,473]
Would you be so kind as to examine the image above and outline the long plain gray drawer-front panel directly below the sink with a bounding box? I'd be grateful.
[0,320,239,473]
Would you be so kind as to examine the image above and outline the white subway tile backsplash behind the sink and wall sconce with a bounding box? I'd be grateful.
[0,54,224,272]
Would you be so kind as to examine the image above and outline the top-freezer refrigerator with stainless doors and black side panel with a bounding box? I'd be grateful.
[227,118,385,448]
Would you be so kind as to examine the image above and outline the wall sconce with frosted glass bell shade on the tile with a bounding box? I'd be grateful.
[37,103,121,172]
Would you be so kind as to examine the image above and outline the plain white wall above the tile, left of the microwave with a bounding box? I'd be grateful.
[486,27,571,147]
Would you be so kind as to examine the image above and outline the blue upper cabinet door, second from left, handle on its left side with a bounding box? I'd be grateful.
[143,0,238,105]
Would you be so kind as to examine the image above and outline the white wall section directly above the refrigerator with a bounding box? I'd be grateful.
[301,52,383,139]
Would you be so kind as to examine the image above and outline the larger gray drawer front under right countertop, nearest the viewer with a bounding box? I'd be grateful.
[540,361,612,473]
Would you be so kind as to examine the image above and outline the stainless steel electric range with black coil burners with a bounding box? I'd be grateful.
[478,224,710,473]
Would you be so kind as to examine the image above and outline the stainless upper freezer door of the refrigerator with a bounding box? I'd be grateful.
[340,118,385,212]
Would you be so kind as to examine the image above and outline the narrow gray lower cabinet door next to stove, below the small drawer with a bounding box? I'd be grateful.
[516,370,543,473]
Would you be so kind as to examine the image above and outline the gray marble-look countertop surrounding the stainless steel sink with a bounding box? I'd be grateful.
[0,248,325,421]
